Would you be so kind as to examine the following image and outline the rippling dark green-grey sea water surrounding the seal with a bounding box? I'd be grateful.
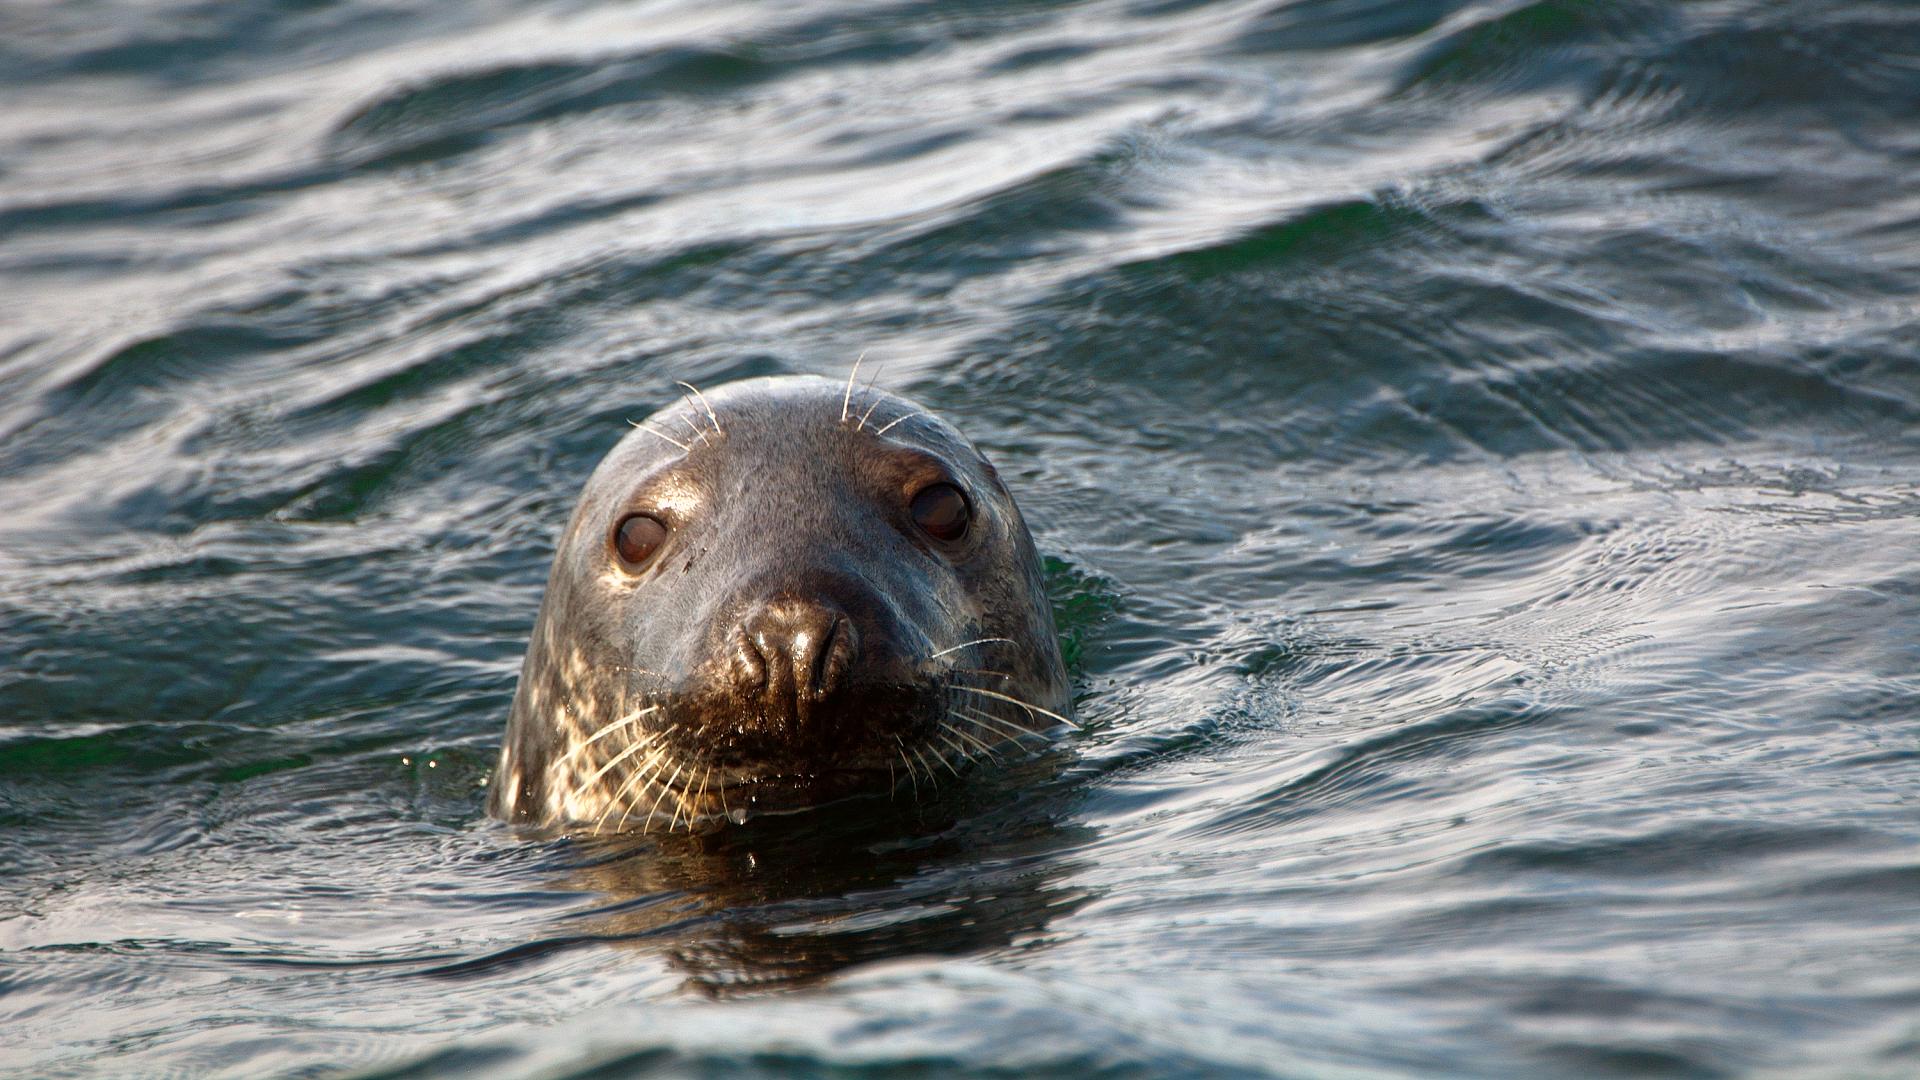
[0,0,1920,1076]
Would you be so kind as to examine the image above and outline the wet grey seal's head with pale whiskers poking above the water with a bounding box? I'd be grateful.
[490,365,1071,832]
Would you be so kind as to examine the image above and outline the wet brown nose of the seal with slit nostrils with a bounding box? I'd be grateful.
[733,596,860,721]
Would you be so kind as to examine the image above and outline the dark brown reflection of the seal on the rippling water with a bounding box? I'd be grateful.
[549,757,1091,995]
